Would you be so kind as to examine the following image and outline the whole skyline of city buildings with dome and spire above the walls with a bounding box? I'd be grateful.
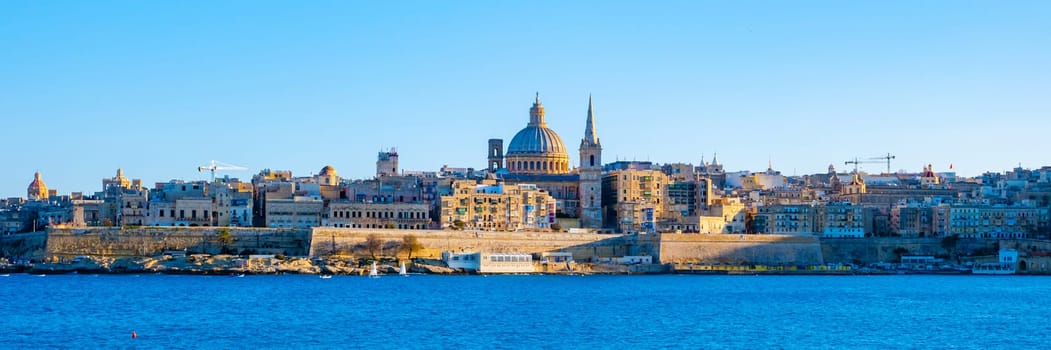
[0,95,1051,238]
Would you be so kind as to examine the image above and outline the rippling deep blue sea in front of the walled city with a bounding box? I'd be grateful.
[0,273,1051,349]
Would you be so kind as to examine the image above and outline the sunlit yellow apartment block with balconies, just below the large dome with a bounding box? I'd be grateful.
[440,180,556,231]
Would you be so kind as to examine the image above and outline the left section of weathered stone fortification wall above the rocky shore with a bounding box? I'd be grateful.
[46,227,310,259]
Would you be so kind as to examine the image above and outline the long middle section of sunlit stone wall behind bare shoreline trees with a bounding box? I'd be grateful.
[310,227,656,261]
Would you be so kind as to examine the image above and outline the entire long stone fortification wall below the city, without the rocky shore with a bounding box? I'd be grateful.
[14,227,1008,266]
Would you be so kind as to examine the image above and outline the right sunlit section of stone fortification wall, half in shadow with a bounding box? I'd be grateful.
[660,233,824,266]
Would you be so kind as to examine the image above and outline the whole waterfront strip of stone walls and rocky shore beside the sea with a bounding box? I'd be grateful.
[0,227,1051,274]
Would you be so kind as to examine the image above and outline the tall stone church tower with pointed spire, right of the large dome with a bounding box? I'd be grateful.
[577,96,602,228]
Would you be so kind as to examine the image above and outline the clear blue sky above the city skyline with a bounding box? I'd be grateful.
[0,0,1051,197]
